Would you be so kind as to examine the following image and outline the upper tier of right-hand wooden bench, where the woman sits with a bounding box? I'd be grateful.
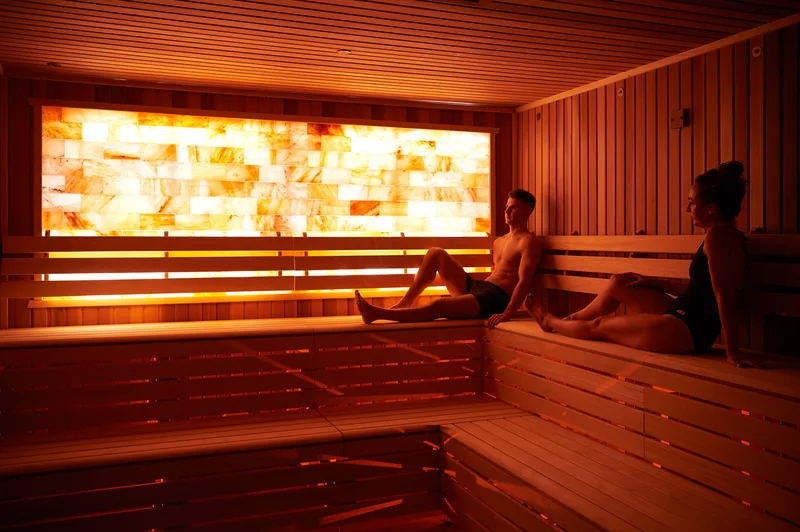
[484,322,800,525]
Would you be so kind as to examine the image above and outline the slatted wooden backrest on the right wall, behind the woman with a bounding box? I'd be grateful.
[539,235,800,317]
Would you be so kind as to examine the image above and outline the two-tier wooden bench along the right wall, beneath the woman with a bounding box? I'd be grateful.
[442,321,800,532]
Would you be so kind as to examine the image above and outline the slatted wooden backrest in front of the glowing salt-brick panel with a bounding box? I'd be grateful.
[0,236,492,298]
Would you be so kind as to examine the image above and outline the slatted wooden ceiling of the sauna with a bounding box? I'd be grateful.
[0,0,800,106]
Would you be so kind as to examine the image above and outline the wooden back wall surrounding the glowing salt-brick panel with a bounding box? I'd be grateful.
[2,77,510,327]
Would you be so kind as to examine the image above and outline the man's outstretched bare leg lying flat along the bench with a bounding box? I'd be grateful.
[356,290,480,324]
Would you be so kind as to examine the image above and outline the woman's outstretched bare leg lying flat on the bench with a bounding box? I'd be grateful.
[525,294,694,353]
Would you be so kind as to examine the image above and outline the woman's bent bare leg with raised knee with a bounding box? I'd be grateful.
[567,275,674,320]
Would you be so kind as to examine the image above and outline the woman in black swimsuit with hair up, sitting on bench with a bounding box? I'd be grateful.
[525,161,756,367]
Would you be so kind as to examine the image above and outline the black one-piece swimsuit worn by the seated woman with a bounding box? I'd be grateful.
[664,234,747,353]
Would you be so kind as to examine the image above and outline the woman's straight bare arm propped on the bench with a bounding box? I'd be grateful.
[704,228,752,366]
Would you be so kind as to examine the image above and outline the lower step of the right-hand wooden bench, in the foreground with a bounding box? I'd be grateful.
[442,415,797,532]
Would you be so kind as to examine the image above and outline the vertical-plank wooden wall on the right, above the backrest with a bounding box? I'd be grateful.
[518,25,800,352]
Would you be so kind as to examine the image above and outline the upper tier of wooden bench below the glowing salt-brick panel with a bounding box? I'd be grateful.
[0,317,483,437]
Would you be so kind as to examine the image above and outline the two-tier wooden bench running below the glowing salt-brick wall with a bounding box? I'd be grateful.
[0,317,522,531]
